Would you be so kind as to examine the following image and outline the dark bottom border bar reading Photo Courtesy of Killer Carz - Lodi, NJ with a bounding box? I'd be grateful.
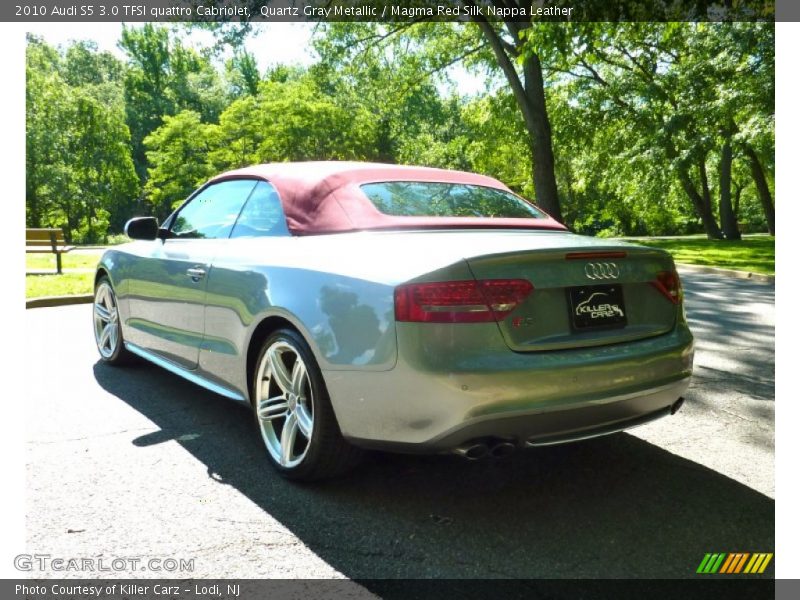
[0,575,788,600]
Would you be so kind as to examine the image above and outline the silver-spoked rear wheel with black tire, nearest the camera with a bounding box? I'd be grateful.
[251,329,362,481]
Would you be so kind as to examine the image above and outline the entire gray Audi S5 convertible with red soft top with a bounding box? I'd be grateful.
[93,162,693,480]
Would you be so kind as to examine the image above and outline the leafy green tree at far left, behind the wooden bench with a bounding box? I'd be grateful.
[26,37,137,242]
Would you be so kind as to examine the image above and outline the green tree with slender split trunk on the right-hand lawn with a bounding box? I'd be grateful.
[550,23,771,239]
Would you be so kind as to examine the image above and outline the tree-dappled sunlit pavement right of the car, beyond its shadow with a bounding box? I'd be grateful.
[632,273,775,498]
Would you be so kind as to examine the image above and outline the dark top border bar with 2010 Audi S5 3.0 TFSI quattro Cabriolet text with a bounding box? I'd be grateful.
[0,0,784,23]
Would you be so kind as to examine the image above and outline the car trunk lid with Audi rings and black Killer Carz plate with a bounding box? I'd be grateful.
[466,239,680,352]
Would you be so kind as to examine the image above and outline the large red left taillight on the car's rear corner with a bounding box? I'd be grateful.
[394,279,533,323]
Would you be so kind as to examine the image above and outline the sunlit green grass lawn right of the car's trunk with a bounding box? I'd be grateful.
[628,235,775,275]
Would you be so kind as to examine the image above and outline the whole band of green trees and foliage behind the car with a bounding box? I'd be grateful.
[26,22,775,241]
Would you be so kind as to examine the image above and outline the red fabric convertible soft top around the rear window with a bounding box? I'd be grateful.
[212,161,566,235]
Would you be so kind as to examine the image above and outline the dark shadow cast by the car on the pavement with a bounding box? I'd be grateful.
[94,363,775,579]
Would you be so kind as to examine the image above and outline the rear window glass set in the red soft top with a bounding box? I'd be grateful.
[361,181,546,219]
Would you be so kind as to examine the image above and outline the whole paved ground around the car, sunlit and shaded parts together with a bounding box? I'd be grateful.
[26,275,774,580]
